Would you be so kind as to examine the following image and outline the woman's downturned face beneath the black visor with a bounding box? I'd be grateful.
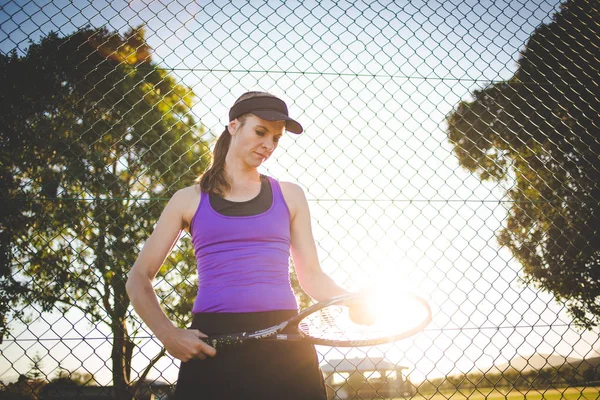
[229,114,285,168]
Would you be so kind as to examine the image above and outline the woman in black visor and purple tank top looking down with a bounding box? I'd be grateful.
[127,92,347,400]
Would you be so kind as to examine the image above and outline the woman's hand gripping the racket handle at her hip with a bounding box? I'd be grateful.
[159,328,217,362]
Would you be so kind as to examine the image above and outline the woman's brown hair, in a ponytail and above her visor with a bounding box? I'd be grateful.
[196,92,276,196]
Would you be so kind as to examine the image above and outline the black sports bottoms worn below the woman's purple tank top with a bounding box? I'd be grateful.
[175,310,327,400]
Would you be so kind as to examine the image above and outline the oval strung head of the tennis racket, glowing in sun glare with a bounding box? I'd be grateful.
[289,291,432,347]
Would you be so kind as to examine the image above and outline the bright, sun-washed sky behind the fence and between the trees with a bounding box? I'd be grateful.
[0,0,600,383]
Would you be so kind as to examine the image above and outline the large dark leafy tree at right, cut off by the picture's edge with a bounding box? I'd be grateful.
[447,0,600,328]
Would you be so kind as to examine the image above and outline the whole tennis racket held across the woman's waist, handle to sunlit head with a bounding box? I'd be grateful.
[202,292,431,349]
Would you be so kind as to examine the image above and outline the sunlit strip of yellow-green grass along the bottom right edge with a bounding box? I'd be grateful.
[408,386,600,400]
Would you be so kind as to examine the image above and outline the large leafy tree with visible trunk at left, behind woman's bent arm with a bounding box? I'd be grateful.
[0,28,209,399]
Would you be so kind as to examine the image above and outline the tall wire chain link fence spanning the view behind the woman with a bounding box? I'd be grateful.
[0,0,600,399]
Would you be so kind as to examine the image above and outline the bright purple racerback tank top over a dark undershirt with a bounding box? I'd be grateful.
[191,178,298,313]
